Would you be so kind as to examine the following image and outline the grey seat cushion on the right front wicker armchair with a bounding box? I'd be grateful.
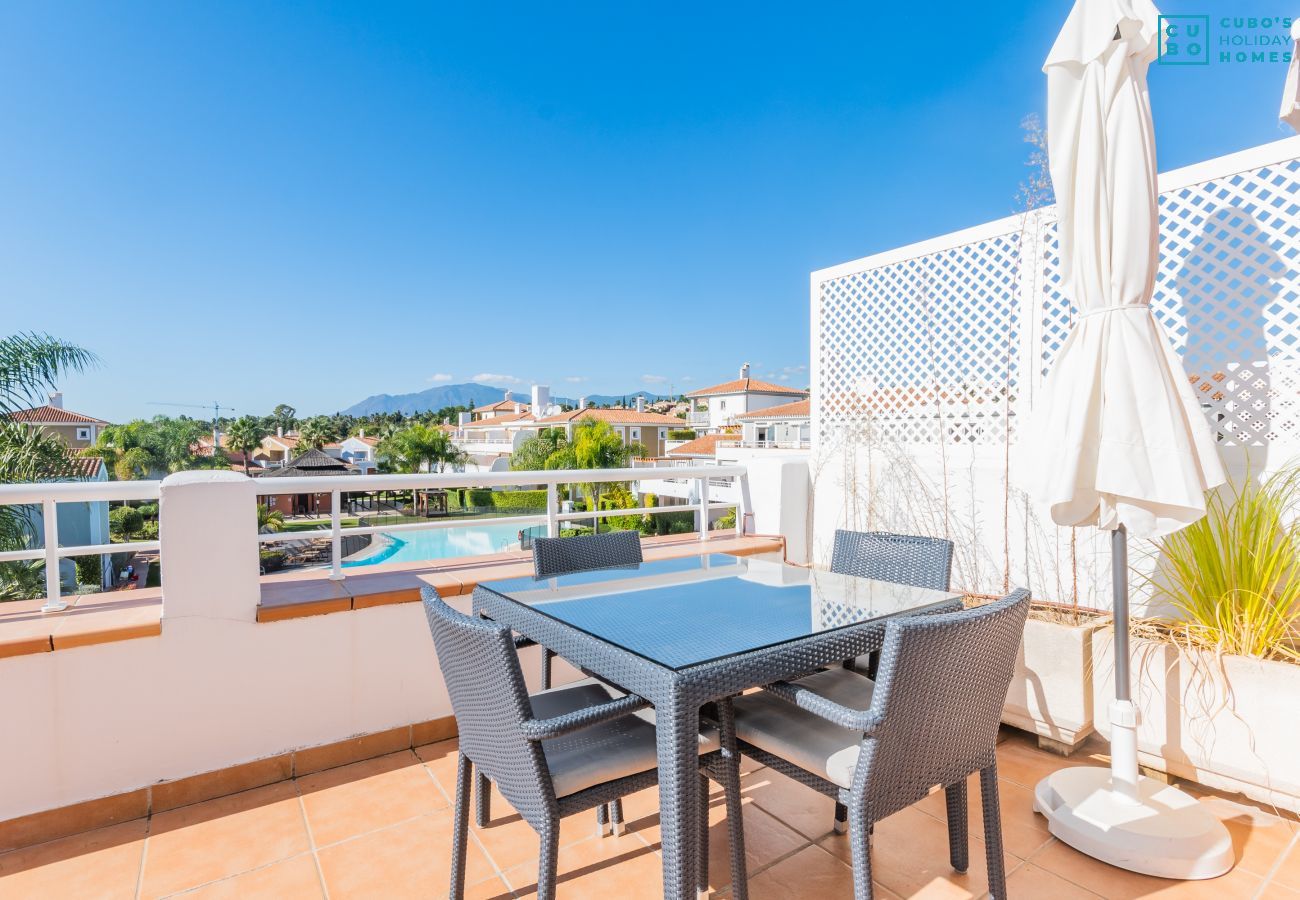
[733,668,875,788]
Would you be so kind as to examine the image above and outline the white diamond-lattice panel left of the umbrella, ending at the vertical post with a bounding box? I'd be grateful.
[818,233,1019,443]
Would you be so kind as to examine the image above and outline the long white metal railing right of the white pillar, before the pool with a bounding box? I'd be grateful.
[256,464,749,580]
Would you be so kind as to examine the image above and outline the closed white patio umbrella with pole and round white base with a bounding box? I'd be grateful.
[1019,0,1232,878]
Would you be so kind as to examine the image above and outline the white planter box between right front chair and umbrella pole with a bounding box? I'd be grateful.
[1002,619,1097,750]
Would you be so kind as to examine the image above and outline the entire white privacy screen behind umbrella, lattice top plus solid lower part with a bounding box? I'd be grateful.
[811,138,1300,606]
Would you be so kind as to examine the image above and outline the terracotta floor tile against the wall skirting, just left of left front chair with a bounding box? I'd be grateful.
[298,750,447,847]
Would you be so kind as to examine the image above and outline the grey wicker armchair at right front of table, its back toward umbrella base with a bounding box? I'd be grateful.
[735,589,1030,900]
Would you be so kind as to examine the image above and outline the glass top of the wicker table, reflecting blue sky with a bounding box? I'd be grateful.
[481,555,961,668]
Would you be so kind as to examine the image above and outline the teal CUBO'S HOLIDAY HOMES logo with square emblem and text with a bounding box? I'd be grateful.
[1158,16,1295,65]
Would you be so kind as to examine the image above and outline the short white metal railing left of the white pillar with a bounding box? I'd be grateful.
[0,481,161,613]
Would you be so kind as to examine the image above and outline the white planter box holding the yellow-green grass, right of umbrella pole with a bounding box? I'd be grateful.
[1093,629,1300,812]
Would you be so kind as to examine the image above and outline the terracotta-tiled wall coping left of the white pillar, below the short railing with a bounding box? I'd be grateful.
[0,588,163,658]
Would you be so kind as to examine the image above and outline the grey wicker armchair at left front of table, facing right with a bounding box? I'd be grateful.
[421,588,745,900]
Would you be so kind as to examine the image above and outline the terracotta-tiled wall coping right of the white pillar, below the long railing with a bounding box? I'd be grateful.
[257,535,784,622]
